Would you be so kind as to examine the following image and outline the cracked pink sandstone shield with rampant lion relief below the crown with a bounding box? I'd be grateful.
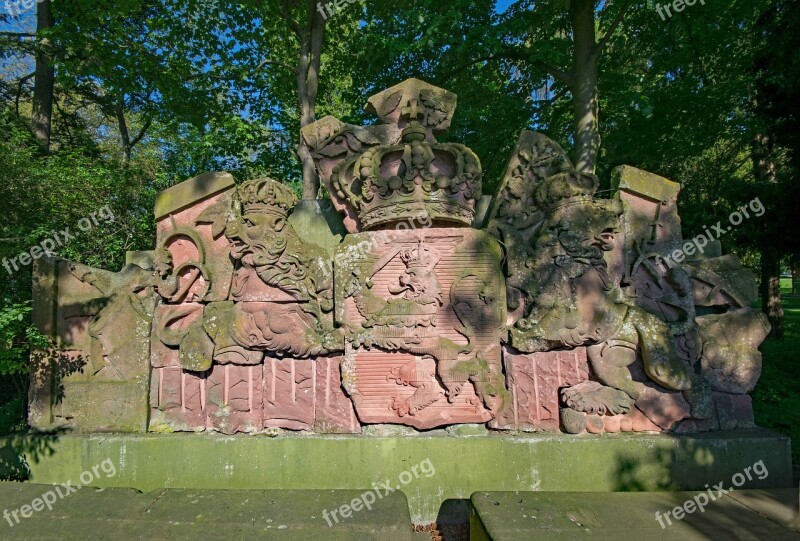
[335,228,510,428]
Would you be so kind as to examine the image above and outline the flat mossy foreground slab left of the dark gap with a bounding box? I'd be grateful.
[0,483,412,541]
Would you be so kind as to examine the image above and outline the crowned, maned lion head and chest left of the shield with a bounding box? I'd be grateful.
[225,178,344,357]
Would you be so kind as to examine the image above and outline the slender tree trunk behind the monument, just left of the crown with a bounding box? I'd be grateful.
[297,0,325,200]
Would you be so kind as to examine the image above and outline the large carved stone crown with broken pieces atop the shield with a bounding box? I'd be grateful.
[304,79,482,232]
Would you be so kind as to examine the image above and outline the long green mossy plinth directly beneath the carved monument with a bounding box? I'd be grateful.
[0,429,792,525]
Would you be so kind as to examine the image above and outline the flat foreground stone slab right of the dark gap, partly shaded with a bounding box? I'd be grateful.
[470,490,800,541]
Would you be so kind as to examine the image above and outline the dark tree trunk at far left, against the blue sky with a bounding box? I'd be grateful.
[31,0,55,152]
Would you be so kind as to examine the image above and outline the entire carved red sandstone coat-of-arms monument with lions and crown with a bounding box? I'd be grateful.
[30,79,769,434]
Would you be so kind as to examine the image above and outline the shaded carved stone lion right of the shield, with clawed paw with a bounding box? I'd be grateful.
[495,135,713,432]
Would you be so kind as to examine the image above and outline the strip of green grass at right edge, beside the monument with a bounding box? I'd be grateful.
[753,279,800,464]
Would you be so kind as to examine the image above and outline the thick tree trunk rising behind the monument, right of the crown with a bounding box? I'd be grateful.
[569,0,600,173]
